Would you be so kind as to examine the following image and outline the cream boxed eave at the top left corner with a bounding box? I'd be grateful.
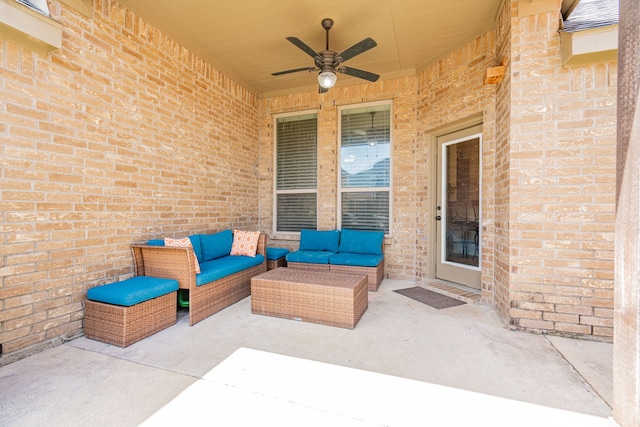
[0,0,62,53]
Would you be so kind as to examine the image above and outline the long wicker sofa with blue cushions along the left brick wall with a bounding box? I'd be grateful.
[131,230,267,326]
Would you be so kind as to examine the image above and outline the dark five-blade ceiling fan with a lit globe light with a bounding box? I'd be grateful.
[271,18,380,93]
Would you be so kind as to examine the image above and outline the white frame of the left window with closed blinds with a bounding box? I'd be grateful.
[272,109,320,239]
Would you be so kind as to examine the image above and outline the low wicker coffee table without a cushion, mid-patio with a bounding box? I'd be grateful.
[251,267,369,329]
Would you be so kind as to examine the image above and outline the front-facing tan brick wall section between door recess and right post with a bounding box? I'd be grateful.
[507,1,617,337]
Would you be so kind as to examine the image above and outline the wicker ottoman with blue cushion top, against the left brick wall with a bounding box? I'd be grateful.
[84,276,178,347]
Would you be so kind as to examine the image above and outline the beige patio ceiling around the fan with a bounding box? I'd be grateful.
[119,0,501,97]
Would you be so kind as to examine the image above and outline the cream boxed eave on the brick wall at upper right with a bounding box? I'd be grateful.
[560,25,618,67]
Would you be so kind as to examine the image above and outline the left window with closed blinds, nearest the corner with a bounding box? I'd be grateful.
[274,113,318,232]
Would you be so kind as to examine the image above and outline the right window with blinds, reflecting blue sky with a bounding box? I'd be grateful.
[338,102,391,234]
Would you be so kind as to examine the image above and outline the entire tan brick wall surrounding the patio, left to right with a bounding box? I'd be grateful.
[0,0,616,362]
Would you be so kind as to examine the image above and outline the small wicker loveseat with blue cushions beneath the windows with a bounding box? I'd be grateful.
[286,228,384,291]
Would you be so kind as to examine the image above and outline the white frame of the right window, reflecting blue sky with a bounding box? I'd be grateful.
[336,99,394,237]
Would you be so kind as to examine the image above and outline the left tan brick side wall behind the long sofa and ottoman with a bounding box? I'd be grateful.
[0,0,258,360]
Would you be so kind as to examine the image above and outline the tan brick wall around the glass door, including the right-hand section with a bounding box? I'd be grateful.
[416,0,616,339]
